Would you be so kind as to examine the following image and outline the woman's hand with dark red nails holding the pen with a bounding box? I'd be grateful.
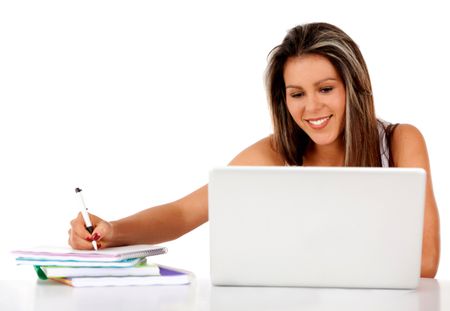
[69,213,113,250]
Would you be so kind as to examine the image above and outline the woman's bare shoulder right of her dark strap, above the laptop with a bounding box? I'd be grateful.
[391,124,428,167]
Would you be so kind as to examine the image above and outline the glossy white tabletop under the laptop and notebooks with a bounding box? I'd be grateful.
[0,279,450,311]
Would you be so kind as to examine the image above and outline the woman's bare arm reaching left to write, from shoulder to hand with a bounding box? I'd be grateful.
[69,137,284,249]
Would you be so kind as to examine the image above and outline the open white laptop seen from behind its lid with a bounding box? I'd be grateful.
[208,166,426,289]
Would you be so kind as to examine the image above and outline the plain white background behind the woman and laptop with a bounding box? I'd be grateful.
[0,0,450,279]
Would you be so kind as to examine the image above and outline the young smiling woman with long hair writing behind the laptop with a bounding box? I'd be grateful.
[69,23,440,277]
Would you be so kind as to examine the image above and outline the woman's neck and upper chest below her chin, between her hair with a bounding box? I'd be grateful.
[303,142,345,166]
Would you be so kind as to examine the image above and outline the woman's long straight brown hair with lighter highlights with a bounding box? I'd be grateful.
[266,23,388,167]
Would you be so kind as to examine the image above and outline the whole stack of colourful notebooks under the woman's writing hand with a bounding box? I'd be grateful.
[12,244,190,287]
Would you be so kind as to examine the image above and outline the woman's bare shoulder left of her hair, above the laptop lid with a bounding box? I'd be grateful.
[229,135,285,166]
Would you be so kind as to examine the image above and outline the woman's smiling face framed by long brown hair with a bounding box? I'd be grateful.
[284,54,345,145]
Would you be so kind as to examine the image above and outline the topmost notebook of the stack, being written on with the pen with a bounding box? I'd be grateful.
[12,244,167,264]
